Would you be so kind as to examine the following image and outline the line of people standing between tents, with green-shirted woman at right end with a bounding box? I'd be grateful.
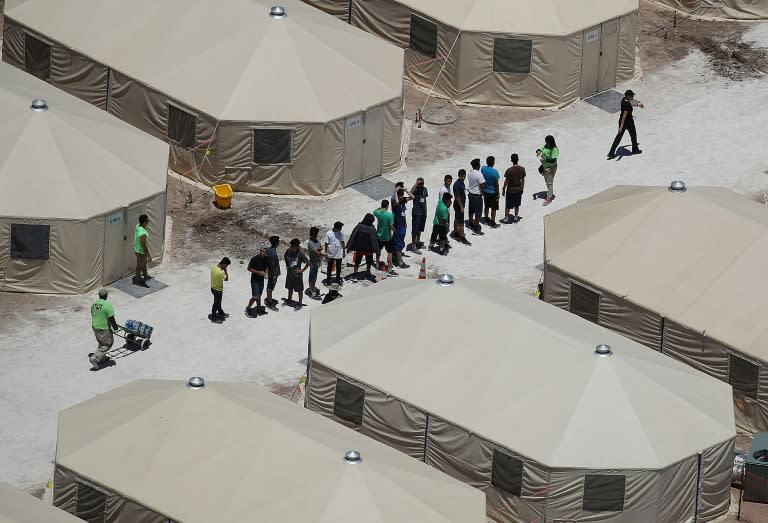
[208,135,560,323]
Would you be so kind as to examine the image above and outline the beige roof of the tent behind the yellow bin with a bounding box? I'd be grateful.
[6,0,403,123]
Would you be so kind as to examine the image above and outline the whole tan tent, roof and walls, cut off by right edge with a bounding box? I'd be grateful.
[543,186,768,432]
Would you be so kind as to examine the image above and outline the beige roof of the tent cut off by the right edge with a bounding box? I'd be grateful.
[545,187,768,361]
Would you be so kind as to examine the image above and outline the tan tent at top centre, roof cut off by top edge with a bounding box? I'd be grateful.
[307,0,639,107]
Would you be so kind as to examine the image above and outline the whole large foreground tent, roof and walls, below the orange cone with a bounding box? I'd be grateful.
[307,279,735,523]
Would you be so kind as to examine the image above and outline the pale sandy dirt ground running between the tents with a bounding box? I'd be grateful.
[0,3,768,521]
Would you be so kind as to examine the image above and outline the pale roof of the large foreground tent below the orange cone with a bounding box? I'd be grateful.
[311,280,735,469]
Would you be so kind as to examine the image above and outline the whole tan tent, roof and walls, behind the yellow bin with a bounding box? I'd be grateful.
[3,0,403,195]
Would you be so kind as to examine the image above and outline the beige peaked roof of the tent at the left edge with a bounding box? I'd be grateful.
[0,63,168,220]
